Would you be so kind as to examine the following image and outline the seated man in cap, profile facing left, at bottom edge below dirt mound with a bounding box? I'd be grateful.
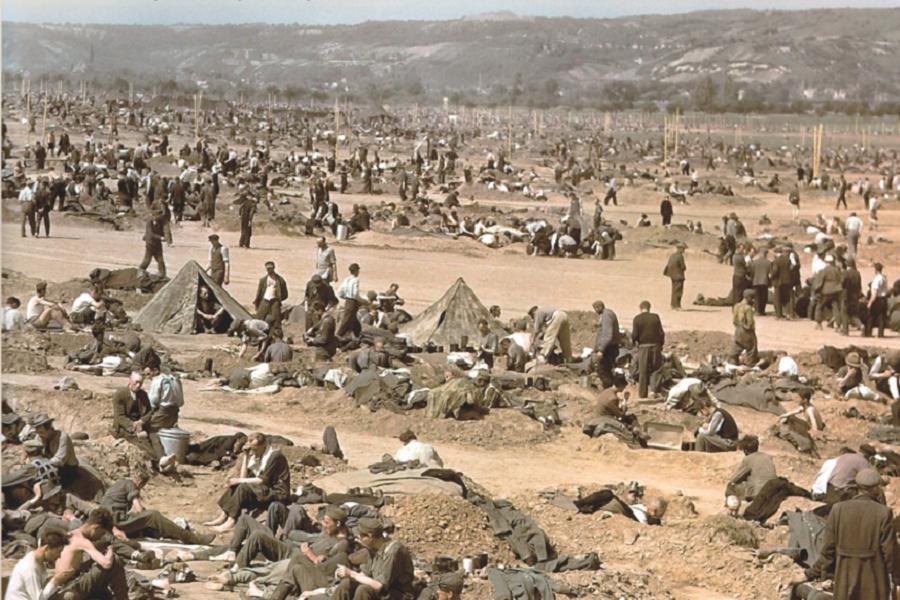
[331,517,414,600]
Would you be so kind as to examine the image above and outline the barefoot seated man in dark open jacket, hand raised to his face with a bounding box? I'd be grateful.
[205,433,291,533]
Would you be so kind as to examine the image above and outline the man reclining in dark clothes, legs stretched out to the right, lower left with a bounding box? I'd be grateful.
[68,470,216,545]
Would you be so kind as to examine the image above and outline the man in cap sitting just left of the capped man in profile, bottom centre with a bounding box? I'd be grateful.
[262,505,349,600]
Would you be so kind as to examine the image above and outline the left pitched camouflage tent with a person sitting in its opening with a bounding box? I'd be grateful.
[134,260,252,333]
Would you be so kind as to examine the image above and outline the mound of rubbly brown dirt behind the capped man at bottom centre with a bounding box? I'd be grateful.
[381,495,515,564]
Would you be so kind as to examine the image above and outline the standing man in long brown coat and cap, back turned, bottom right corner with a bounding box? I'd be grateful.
[805,468,898,600]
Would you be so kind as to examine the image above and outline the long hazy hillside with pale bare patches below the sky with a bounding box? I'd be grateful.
[3,8,900,105]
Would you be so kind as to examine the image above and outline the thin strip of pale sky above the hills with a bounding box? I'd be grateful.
[7,0,900,25]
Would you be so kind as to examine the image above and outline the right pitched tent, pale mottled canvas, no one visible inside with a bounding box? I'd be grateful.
[400,277,500,346]
